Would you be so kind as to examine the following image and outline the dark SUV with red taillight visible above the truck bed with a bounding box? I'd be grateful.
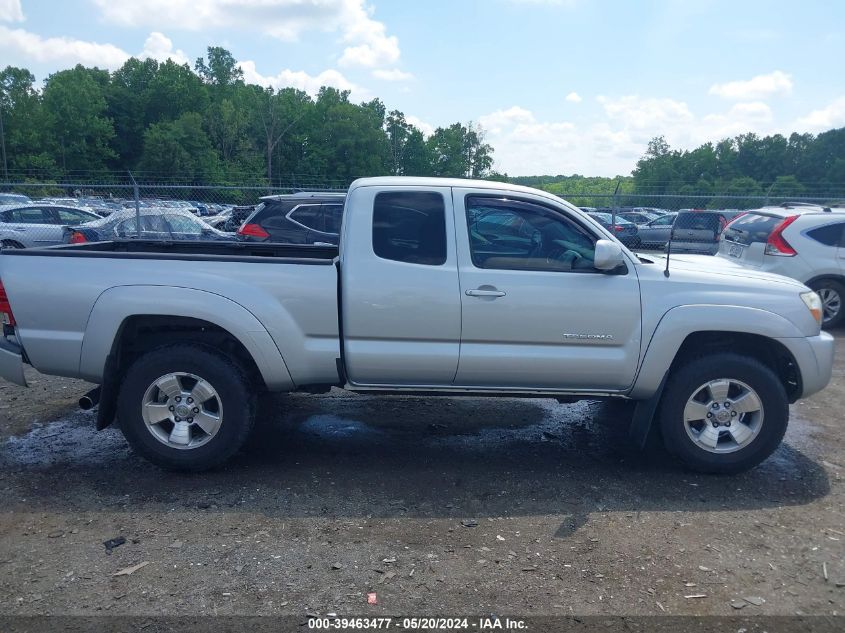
[238,192,346,245]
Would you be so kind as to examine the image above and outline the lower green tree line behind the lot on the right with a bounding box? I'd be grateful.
[510,128,845,208]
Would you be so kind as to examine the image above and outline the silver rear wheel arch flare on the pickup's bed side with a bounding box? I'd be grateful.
[79,286,294,391]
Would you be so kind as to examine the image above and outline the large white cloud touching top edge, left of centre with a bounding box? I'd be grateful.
[94,0,400,68]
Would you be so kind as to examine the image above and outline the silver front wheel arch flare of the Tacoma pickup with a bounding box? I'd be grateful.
[629,305,804,400]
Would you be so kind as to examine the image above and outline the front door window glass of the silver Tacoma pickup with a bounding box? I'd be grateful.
[466,196,595,272]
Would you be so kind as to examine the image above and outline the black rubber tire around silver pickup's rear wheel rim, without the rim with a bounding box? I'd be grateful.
[117,345,256,472]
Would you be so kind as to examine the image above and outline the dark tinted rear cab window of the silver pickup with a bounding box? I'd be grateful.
[373,191,446,266]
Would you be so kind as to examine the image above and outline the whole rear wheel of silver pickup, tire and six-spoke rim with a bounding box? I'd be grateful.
[117,345,255,471]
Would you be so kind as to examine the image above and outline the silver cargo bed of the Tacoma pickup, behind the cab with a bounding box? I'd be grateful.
[0,240,340,388]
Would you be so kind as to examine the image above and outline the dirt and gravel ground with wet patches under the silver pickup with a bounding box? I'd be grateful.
[0,332,845,616]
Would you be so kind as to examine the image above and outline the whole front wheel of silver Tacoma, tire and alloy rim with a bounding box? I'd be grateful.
[659,353,789,473]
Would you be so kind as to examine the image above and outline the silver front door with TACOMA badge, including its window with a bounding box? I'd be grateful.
[453,189,641,392]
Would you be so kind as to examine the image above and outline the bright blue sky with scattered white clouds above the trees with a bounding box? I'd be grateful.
[0,0,845,176]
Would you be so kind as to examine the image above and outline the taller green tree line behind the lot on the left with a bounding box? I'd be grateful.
[0,47,493,186]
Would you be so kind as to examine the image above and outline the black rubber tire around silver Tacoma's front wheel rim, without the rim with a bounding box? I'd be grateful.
[658,352,789,474]
